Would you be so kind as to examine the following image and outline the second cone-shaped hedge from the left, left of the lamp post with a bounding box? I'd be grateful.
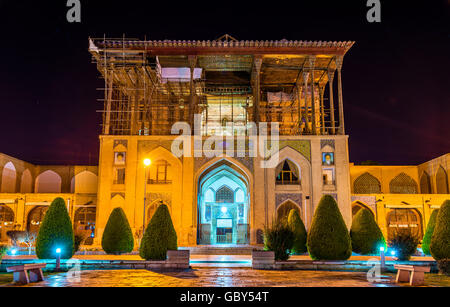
[102,207,134,255]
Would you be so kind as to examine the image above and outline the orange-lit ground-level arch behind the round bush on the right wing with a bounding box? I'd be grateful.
[386,209,422,240]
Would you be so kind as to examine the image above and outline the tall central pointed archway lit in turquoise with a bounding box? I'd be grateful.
[197,160,250,245]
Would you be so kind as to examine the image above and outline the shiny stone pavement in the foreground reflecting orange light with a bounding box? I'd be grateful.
[12,267,395,287]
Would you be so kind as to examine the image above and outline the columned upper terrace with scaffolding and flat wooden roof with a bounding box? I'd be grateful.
[89,35,354,135]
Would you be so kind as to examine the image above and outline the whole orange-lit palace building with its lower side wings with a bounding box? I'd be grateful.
[0,35,450,246]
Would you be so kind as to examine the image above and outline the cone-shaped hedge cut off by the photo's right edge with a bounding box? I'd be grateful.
[430,200,450,260]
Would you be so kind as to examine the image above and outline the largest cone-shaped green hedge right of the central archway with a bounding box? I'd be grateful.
[307,195,352,260]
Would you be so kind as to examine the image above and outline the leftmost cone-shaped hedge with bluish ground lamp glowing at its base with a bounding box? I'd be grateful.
[36,197,74,259]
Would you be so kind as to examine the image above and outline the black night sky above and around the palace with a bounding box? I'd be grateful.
[0,0,450,165]
